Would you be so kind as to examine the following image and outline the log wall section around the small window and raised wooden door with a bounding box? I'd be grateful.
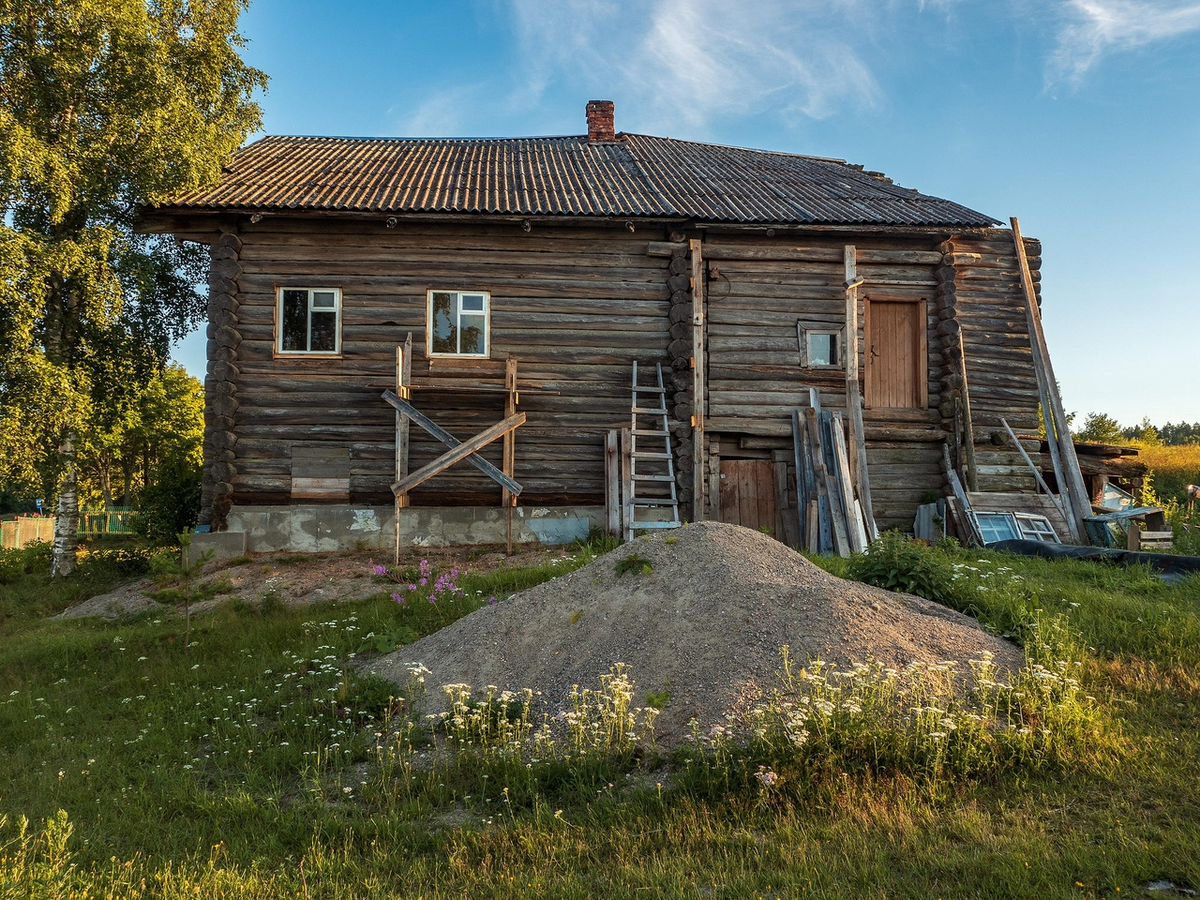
[707,235,944,527]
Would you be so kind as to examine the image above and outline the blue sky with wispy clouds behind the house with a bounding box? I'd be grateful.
[178,0,1200,424]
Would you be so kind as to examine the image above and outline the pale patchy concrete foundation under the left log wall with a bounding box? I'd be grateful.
[218,504,605,556]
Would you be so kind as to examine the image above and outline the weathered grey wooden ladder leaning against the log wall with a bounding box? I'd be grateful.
[624,361,680,540]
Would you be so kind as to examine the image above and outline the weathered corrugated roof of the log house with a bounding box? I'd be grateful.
[170,133,996,227]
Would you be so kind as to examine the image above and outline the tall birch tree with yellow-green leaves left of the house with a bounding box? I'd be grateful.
[0,0,266,576]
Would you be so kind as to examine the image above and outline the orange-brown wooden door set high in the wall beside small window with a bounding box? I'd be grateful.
[863,299,929,409]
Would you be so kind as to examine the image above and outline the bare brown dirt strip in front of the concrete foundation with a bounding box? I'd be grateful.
[55,547,573,619]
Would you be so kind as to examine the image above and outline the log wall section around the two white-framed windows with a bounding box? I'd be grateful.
[234,220,667,505]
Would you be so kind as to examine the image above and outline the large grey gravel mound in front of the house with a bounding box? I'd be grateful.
[370,522,1022,745]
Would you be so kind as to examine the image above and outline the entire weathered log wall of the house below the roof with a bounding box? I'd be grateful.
[192,217,1040,528]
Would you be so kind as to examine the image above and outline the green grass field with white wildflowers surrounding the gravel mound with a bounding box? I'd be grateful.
[0,540,1200,898]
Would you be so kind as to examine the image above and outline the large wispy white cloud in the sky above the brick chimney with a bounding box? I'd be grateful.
[501,0,888,133]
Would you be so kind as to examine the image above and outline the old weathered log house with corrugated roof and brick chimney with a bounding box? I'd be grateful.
[139,101,1040,548]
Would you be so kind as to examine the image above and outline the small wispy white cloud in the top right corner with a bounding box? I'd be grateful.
[1049,0,1200,84]
